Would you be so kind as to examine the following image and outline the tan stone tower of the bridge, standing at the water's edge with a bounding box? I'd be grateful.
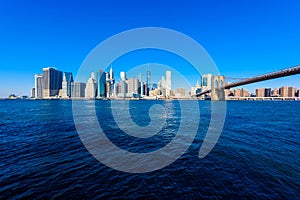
[211,76,225,101]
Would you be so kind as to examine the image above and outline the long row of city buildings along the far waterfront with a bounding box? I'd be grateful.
[18,65,300,99]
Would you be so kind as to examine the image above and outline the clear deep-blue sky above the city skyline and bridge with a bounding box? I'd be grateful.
[0,0,300,97]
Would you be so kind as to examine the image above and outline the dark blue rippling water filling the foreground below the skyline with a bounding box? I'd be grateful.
[0,100,300,199]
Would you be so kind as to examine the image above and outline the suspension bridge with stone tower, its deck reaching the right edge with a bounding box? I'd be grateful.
[196,65,300,101]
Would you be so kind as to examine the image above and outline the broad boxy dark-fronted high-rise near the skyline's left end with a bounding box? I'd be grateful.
[43,67,62,98]
